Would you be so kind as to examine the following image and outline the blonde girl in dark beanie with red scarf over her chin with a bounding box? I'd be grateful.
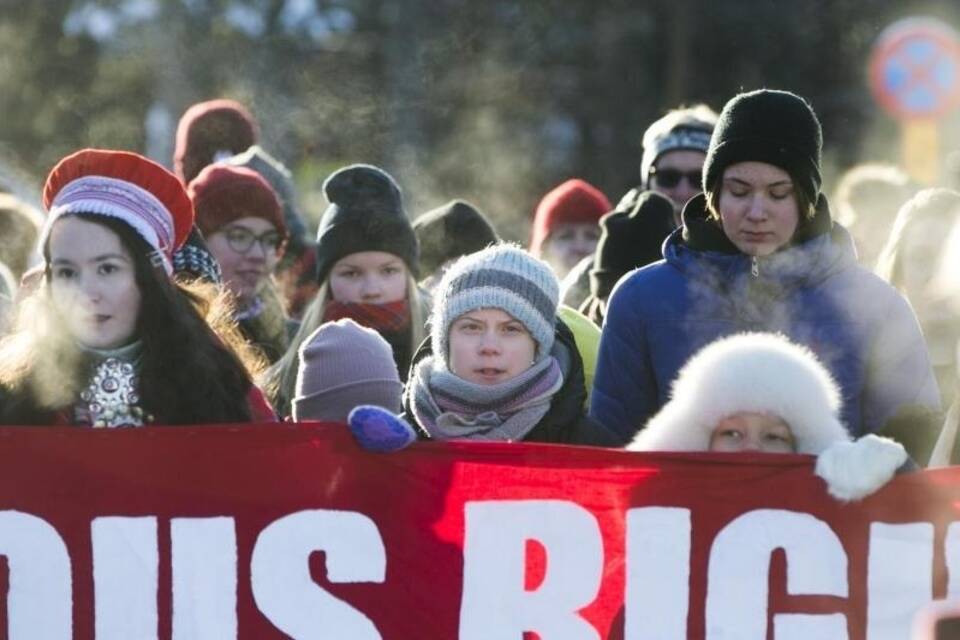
[265,164,429,415]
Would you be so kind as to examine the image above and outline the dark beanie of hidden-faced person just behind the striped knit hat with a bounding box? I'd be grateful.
[413,200,500,277]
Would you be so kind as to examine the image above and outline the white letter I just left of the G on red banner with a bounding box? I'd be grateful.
[623,507,690,640]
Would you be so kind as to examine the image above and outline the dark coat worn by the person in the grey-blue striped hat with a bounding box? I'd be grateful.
[403,319,616,446]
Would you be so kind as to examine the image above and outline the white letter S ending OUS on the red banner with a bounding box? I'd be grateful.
[250,509,387,640]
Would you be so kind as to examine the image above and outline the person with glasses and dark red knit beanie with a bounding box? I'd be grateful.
[187,163,295,363]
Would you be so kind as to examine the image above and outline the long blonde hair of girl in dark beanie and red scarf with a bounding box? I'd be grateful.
[259,269,426,416]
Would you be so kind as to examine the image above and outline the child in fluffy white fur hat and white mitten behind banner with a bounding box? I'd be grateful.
[628,333,908,500]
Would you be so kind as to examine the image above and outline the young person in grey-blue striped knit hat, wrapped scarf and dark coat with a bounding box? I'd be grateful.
[404,244,606,444]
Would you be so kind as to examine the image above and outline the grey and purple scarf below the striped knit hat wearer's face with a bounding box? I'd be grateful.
[408,356,563,442]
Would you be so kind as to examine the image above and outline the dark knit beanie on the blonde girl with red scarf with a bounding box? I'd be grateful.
[317,164,419,283]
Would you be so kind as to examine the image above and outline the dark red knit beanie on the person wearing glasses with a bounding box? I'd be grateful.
[187,164,287,236]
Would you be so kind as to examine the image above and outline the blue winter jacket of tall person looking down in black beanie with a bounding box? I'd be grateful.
[590,195,939,442]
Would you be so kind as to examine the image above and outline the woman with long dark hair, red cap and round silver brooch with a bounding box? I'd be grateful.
[0,149,276,427]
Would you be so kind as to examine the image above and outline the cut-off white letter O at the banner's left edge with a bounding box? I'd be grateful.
[0,511,73,640]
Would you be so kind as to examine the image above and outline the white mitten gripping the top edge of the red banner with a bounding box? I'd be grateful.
[814,434,908,502]
